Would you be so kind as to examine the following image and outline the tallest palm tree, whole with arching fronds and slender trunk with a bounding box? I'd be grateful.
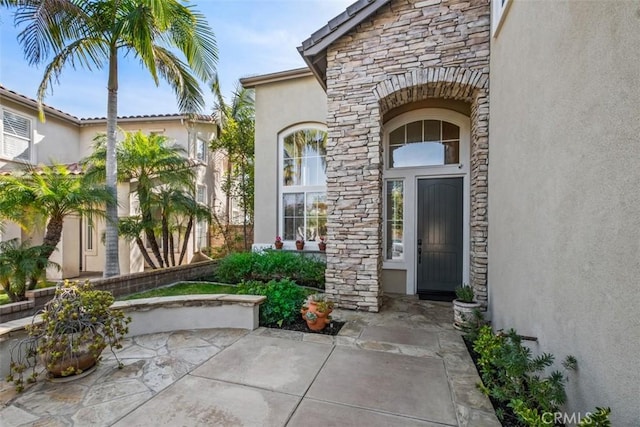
[0,0,218,277]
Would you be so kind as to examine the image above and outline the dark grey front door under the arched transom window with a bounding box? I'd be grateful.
[417,178,463,300]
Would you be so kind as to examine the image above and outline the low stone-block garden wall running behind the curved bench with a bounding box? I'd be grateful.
[0,261,217,323]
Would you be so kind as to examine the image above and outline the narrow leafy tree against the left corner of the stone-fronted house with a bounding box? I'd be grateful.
[211,76,255,249]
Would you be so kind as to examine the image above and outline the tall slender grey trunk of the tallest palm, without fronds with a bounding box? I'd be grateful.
[103,45,120,277]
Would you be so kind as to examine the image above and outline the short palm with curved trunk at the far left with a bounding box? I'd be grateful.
[0,164,115,259]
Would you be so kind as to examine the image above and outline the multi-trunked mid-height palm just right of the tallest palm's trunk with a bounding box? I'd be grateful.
[83,132,195,268]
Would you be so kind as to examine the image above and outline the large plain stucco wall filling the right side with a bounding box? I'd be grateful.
[489,1,640,426]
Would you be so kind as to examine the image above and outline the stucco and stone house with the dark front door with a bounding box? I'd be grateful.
[242,0,640,426]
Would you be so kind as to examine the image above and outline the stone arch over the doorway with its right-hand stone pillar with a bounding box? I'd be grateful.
[372,67,489,306]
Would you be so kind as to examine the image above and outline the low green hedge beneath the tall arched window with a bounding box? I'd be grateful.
[215,251,326,289]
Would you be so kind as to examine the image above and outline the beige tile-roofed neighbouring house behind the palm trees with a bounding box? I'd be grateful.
[0,86,226,279]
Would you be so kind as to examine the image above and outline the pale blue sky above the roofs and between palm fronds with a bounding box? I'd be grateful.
[0,0,355,117]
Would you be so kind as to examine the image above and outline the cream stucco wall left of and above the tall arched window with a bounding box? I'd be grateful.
[254,76,327,243]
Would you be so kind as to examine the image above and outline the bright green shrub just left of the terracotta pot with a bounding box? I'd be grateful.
[238,279,306,326]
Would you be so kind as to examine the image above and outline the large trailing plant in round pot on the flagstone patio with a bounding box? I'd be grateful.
[7,281,131,391]
